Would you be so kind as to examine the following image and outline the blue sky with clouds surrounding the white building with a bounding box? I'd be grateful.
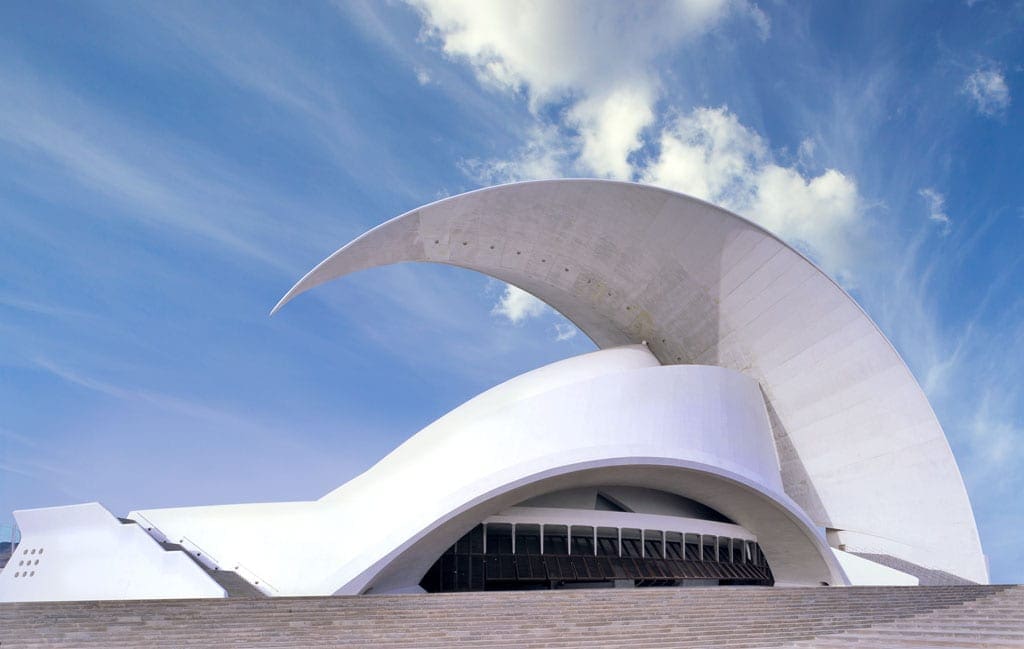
[0,0,1024,582]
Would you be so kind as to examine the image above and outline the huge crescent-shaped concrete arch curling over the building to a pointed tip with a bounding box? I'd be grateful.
[273,180,988,582]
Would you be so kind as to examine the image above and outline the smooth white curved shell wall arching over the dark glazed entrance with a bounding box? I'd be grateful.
[130,346,845,595]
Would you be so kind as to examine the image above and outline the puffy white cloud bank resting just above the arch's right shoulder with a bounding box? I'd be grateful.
[641,107,862,277]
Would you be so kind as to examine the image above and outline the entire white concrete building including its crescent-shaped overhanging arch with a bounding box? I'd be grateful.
[0,180,988,601]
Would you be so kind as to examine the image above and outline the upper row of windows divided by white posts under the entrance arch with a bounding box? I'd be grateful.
[445,523,765,566]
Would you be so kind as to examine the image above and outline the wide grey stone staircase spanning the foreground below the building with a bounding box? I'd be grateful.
[0,586,1024,649]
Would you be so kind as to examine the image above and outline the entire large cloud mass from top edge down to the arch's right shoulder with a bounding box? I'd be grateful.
[413,0,862,276]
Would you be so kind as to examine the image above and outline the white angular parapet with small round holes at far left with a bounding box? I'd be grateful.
[0,503,226,602]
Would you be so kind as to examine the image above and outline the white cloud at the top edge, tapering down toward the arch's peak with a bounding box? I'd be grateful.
[411,0,770,178]
